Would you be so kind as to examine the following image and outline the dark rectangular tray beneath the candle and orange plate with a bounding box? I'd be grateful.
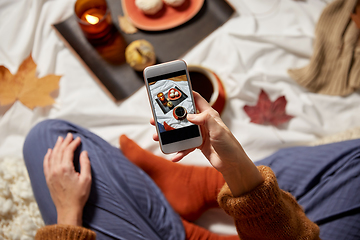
[54,0,234,101]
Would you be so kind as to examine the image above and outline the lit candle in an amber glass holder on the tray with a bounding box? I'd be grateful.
[75,0,113,44]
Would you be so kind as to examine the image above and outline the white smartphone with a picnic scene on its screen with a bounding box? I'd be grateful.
[143,60,203,153]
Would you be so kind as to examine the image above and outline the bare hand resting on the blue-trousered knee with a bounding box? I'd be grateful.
[44,133,91,226]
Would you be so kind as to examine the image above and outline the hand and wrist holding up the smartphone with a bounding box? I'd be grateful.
[150,92,264,196]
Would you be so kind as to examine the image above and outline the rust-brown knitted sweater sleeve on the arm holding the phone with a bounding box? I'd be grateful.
[218,166,320,240]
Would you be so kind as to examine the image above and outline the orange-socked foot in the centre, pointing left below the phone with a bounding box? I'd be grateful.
[120,135,225,221]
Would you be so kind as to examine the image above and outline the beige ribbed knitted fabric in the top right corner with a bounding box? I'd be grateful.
[288,0,360,96]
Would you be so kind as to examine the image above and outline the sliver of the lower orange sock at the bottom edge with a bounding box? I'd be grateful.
[182,219,240,240]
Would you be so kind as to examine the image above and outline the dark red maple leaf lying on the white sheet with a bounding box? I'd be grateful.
[244,90,293,126]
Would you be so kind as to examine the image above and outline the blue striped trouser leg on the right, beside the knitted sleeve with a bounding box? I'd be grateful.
[255,139,360,240]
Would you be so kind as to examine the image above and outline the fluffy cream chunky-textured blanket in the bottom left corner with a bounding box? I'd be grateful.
[0,157,44,240]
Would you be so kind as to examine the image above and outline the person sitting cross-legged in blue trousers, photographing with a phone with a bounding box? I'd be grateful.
[24,93,360,239]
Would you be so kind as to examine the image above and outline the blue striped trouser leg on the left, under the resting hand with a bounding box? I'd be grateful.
[23,120,185,240]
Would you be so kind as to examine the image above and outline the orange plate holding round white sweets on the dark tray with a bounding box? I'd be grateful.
[121,0,204,31]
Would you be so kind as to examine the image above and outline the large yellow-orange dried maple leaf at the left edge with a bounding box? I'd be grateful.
[0,55,61,109]
